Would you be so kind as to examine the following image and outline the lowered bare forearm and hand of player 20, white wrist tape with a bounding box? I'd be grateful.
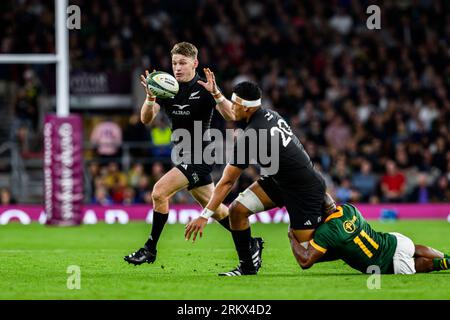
[184,164,243,242]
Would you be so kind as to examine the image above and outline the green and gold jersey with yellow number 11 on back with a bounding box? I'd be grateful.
[310,204,397,273]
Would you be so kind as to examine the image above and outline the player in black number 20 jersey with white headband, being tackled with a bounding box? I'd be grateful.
[185,81,326,276]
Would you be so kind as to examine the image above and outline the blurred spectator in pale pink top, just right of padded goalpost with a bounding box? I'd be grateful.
[90,120,122,163]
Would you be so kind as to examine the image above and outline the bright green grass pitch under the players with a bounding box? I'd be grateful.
[0,221,450,300]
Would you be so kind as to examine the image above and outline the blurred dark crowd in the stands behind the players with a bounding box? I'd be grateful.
[0,0,450,203]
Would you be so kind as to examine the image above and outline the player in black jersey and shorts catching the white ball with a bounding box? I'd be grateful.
[124,42,256,265]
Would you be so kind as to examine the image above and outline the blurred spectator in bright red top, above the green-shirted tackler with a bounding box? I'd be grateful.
[381,160,406,202]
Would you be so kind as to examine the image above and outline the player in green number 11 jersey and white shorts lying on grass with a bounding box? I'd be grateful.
[288,197,450,274]
